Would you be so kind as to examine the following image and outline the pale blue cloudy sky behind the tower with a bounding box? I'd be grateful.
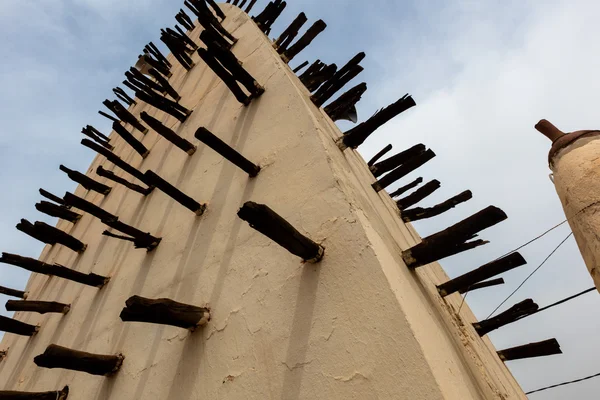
[0,0,600,400]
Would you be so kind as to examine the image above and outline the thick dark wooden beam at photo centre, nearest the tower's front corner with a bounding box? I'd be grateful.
[238,201,325,263]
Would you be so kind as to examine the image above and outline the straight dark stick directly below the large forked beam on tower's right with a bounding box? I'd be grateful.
[437,253,527,297]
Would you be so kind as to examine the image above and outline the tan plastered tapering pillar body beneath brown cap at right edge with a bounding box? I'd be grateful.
[552,136,600,290]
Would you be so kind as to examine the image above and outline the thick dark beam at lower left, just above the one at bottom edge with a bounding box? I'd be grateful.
[33,344,125,376]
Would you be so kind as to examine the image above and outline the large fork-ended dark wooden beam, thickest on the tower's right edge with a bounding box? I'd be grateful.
[402,206,508,269]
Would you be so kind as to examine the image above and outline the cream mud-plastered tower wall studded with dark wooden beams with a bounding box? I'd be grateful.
[0,6,525,400]
